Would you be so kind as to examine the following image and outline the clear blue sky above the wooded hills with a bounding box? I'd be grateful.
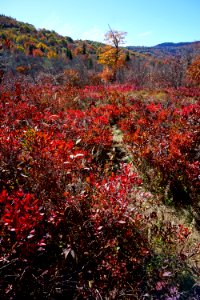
[0,0,200,46]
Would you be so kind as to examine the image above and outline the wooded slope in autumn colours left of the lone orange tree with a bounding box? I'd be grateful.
[0,15,106,82]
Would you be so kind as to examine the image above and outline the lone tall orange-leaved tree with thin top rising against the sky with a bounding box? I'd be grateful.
[98,28,126,81]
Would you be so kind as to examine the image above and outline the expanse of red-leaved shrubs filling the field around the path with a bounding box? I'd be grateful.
[0,82,199,299]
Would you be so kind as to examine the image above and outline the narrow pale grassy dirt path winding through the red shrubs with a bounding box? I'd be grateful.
[112,125,200,276]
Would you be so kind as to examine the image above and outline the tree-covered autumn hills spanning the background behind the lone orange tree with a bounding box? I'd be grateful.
[0,15,200,89]
